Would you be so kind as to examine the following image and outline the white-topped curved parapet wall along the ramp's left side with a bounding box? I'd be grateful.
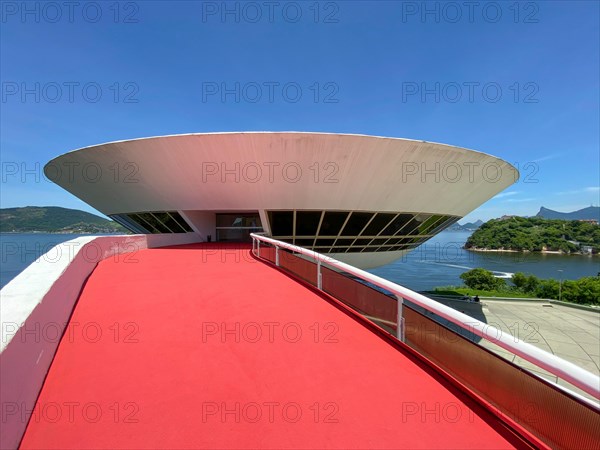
[0,233,200,449]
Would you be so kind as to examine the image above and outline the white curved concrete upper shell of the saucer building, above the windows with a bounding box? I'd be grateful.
[45,132,518,217]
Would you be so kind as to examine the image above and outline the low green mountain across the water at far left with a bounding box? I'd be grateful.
[0,206,128,234]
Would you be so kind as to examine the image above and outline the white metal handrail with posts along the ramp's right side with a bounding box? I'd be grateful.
[250,233,600,400]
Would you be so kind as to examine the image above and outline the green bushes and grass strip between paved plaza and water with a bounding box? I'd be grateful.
[435,268,600,306]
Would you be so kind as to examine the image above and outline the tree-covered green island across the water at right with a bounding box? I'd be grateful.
[465,217,600,253]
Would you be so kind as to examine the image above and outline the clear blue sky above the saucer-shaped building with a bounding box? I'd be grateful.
[0,1,600,220]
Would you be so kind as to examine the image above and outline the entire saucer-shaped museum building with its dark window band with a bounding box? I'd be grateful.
[44,132,518,267]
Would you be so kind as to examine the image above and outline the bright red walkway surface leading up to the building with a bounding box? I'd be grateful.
[22,246,518,449]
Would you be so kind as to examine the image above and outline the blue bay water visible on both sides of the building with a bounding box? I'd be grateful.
[0,231,600,291]
